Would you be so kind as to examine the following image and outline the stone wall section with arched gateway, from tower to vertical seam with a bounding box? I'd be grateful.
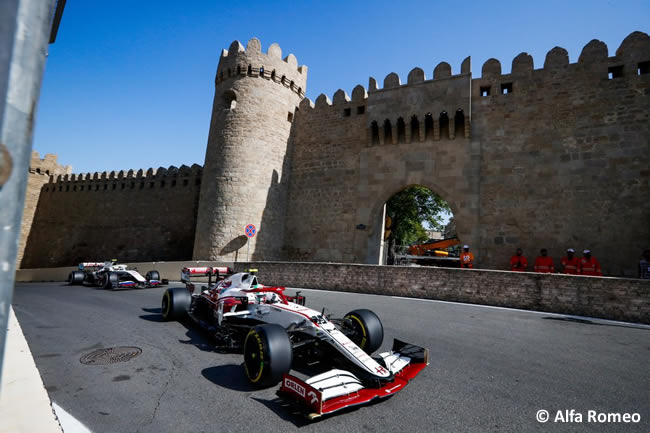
[285,71,480,263]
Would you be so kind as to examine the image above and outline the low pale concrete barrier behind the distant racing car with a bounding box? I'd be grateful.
[16,261,234,282]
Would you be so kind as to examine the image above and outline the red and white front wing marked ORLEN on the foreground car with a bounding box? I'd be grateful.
[278,340,429,419]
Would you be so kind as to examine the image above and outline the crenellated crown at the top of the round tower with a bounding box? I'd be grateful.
[215,38,307,98]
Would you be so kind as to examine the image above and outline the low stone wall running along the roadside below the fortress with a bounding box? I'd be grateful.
[235,262,650,324]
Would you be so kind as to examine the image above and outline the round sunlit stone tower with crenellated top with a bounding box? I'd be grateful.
[193,38,307,260]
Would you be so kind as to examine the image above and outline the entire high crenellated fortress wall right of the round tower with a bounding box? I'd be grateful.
[285,32,650,276]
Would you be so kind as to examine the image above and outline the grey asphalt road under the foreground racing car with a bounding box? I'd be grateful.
[14,283,650,433]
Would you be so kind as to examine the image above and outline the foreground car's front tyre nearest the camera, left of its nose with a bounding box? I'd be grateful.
[244,324,293,387]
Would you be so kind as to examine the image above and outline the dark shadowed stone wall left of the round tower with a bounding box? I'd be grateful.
[20,165,202,268]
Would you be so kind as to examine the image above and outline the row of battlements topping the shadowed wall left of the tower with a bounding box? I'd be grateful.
[43,164,203,192]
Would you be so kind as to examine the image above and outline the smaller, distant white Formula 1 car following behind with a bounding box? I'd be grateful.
[68,259,167,290]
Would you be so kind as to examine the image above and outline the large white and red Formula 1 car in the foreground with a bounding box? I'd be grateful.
[162,268,429,419]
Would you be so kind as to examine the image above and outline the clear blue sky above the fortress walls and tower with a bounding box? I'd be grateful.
[34,0,650,173]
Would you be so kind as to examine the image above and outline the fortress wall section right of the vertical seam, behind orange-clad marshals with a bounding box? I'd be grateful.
[472,33,650,276]
